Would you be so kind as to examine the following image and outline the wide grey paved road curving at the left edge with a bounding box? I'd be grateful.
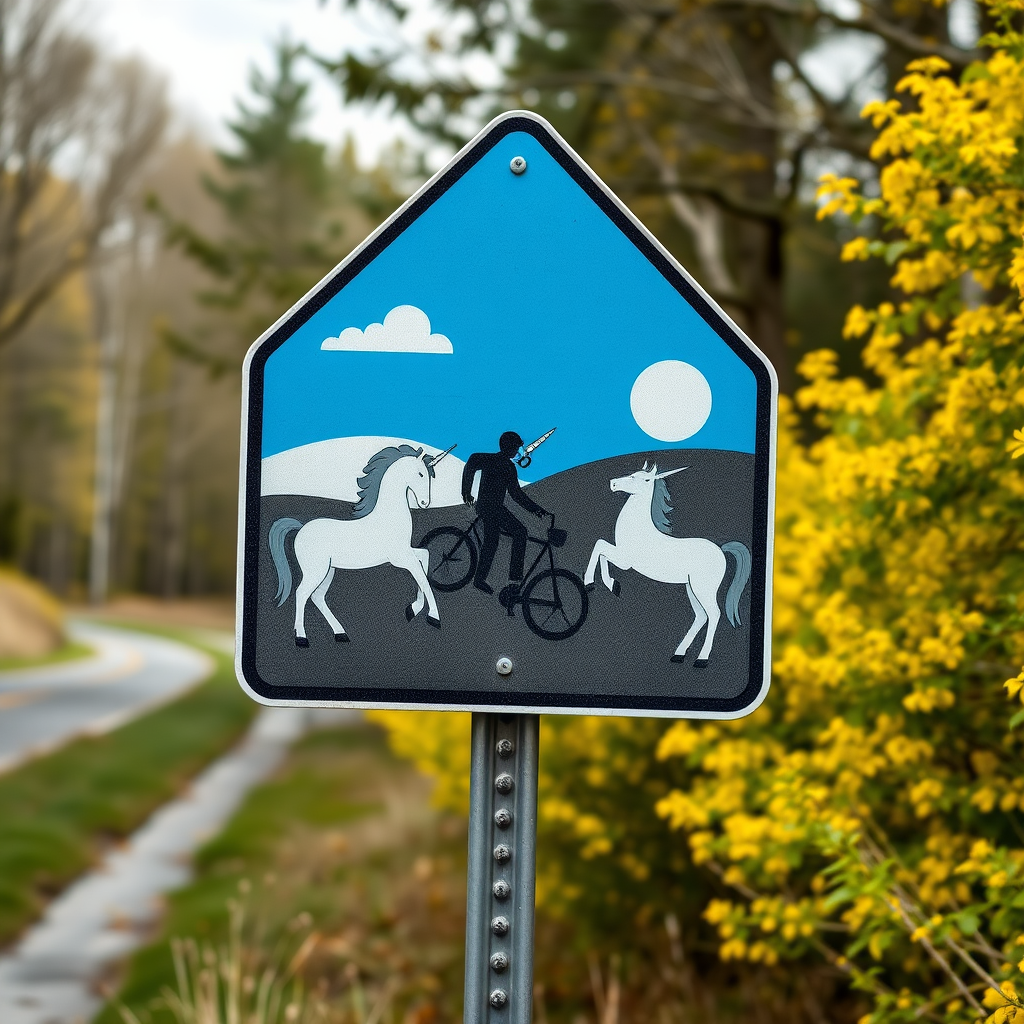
[0,622,213,772]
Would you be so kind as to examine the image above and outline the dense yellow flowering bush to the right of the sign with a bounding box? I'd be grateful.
[382,0,1024,1024]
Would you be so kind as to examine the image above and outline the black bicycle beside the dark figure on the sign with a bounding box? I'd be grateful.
[420,512,589,640]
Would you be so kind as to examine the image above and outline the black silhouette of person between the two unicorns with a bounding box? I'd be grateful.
[462,430,548,594]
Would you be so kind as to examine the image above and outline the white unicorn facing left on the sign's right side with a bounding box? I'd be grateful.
[584,462,751,668]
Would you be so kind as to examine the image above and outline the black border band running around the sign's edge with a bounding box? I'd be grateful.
[238,115,775,718]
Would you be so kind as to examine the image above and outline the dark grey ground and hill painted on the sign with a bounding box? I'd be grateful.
[256,450,754,700]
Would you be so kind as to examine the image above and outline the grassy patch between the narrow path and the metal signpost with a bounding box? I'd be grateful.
[97,723,465,1024]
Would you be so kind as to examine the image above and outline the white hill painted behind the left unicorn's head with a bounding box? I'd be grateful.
[260,437,466,508]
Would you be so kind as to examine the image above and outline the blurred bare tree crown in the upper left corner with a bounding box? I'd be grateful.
[0,0,167,345]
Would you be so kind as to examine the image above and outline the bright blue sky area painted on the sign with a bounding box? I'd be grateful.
[262,133,756,479]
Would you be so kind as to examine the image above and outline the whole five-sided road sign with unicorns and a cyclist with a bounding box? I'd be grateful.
[238,112,777,718]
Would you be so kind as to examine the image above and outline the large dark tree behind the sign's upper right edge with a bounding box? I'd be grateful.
[323,0,973,390]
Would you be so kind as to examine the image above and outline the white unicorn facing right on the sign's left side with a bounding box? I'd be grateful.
[269,444,455,647]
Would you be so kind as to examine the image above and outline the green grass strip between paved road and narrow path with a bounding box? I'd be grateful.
[0,627,256,944]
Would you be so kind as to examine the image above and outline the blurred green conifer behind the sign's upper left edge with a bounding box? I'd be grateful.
[153,42,398,372]
